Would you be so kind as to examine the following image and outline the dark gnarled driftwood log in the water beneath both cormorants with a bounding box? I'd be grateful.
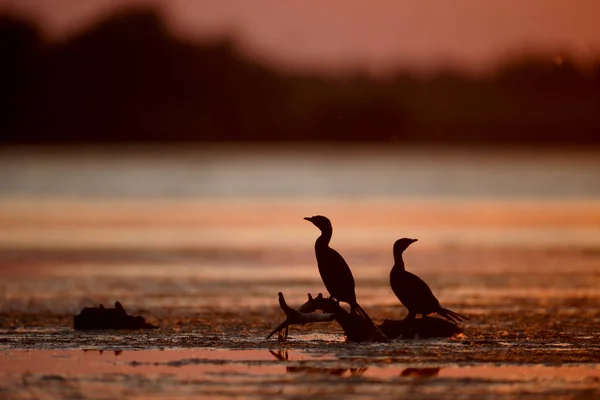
[267,293,462,342]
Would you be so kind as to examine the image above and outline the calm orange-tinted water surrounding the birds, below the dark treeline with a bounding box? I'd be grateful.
[0,147,600,399]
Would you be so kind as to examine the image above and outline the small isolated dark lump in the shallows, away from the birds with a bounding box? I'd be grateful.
[73,301,156,330]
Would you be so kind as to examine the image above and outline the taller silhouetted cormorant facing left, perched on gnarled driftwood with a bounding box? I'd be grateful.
[304,215,370,320]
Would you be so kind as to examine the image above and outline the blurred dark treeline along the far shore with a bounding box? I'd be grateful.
[0,10,600,144]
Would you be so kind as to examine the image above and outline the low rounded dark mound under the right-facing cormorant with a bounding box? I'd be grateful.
[378,317,463,339]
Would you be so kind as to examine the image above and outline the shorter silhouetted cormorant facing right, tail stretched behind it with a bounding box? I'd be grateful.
[390,238,468,323]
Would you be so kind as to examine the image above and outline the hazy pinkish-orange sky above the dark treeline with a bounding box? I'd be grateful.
[0,0,600,71]
